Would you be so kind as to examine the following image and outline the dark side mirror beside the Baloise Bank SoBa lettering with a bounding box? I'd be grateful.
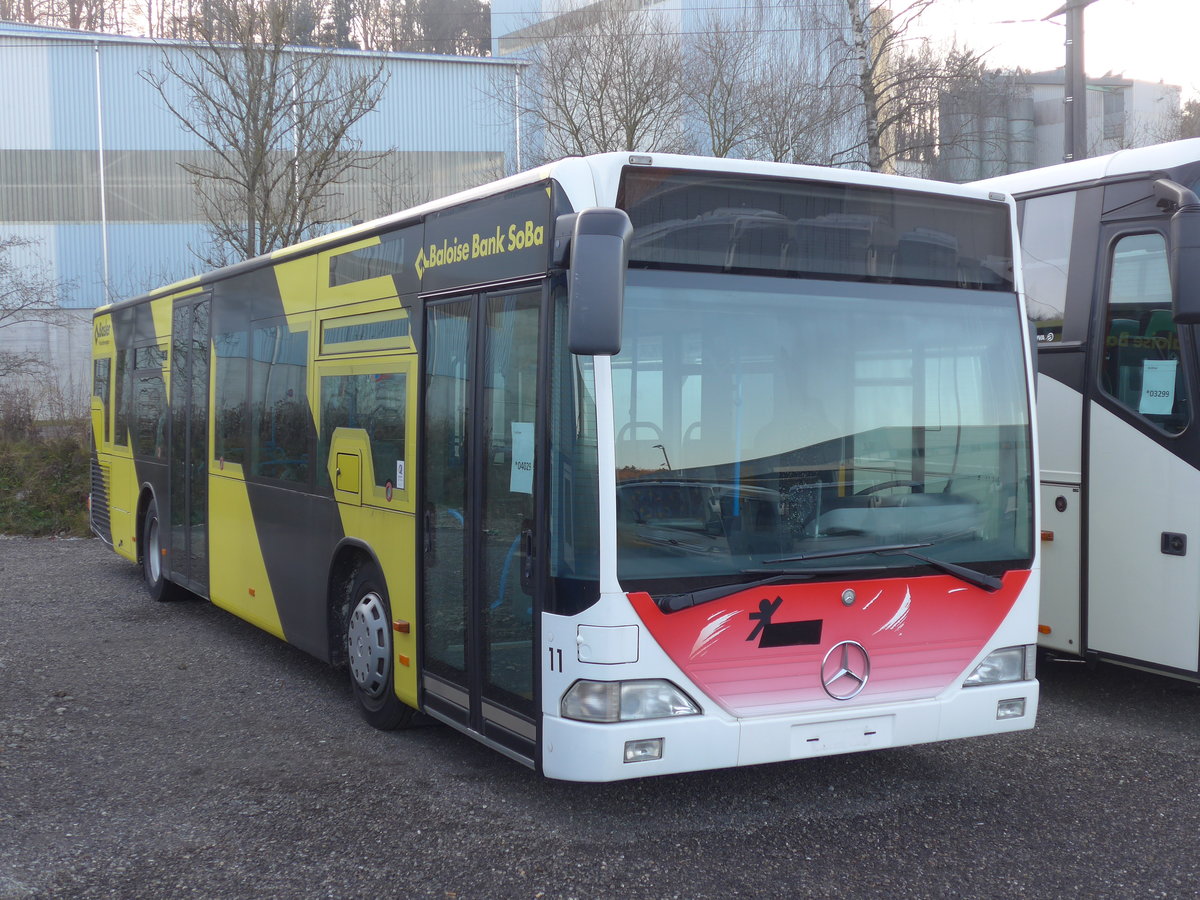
[566,208,634,356]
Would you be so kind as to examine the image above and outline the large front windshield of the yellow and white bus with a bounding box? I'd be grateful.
[612,270,1033,593]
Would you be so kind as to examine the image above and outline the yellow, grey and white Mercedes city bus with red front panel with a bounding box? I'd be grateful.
[91,154,1038,781]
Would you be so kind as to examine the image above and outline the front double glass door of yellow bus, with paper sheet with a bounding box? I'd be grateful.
[421,288,542,760]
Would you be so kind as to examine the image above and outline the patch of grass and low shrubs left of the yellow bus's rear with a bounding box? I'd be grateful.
[0,436,91,538]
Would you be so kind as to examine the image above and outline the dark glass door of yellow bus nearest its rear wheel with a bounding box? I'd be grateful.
[169,294,210,594]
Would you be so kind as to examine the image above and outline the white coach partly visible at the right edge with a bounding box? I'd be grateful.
[976,139,1200,680]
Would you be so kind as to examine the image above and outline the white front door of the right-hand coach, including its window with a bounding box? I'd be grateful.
[1086,224,1200,672]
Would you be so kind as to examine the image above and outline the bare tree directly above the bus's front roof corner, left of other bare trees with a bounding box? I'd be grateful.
[497,0,686,160]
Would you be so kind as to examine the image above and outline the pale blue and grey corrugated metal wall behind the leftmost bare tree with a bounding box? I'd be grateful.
[0,23,525,307]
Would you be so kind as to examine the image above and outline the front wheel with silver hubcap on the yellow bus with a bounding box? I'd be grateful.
[342,563,416,731]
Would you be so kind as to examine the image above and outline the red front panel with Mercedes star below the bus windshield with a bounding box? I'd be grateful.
[629,571,1030,716]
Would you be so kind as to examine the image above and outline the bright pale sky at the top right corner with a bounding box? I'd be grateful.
[922,0,1200,100]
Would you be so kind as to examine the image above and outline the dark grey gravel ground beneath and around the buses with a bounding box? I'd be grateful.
[0,539,1200,900]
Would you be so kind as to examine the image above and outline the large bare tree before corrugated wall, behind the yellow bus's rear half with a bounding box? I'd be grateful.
[142,0,386,265]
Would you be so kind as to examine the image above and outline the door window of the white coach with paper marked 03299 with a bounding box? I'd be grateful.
[1100,234,1190,434]
